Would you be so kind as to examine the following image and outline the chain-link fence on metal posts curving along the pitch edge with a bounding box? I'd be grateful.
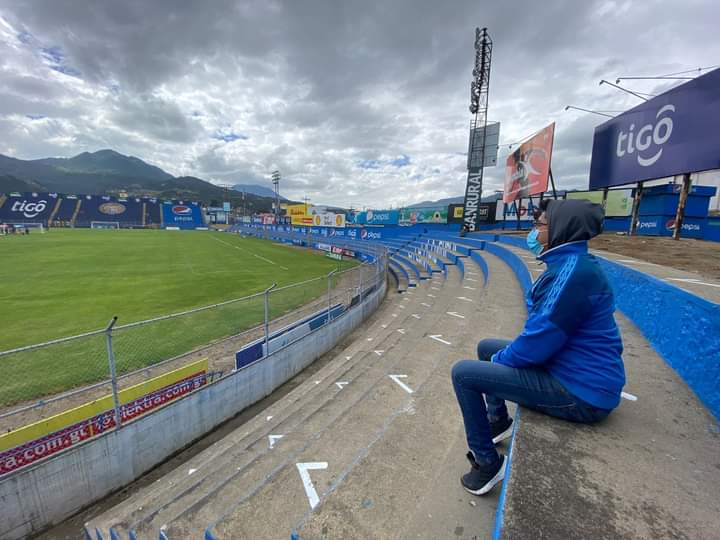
[0,234,387,438]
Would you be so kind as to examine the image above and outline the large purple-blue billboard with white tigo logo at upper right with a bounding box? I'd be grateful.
[590,69,720,190]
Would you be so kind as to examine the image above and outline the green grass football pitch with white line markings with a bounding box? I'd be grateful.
[0,230,355,405]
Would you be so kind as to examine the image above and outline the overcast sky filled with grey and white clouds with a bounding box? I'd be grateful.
[0,0,720,208]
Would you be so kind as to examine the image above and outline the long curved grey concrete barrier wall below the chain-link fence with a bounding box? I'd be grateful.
[0,282,387,540]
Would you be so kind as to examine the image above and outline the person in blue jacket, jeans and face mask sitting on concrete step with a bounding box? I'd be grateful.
[452,200,625,495]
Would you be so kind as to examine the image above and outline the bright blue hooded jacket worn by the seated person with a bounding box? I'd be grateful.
[493,201,625,410]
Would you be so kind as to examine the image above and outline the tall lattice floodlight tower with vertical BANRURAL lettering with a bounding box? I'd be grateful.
[463,28,492,231]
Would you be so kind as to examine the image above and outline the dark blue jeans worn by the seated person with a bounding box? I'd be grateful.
[452,339,610,464]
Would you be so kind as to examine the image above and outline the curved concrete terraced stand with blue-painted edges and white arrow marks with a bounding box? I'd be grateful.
[0,224,720,540]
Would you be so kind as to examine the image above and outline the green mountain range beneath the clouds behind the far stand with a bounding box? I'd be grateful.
[0,150,274,212]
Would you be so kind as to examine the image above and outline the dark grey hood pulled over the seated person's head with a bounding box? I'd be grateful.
[545,199,605,249]
